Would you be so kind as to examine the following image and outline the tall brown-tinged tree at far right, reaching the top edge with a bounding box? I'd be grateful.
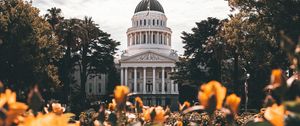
[223,0,300,107]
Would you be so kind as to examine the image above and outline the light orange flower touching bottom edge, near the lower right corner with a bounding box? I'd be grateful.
[264,104,284,126]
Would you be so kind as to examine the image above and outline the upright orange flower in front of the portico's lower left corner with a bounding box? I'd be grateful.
[114,86,129,105]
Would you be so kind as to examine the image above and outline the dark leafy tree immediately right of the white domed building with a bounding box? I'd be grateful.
[173,18,222,101]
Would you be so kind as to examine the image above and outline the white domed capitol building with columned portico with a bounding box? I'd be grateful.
[119,0,178,107]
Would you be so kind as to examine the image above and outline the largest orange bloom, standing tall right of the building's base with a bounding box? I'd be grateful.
[198,81,226,109]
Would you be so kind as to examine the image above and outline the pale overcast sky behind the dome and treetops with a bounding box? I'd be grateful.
[33,0,230,54]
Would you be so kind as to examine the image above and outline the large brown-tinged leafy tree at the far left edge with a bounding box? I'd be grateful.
[0,0,61,94]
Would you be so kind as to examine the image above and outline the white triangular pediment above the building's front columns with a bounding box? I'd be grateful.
[121,51,176,62]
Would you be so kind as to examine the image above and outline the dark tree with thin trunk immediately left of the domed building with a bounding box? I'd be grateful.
[75,17,119,109]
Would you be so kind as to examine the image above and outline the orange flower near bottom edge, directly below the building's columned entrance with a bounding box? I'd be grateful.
[144,106,165,123]
